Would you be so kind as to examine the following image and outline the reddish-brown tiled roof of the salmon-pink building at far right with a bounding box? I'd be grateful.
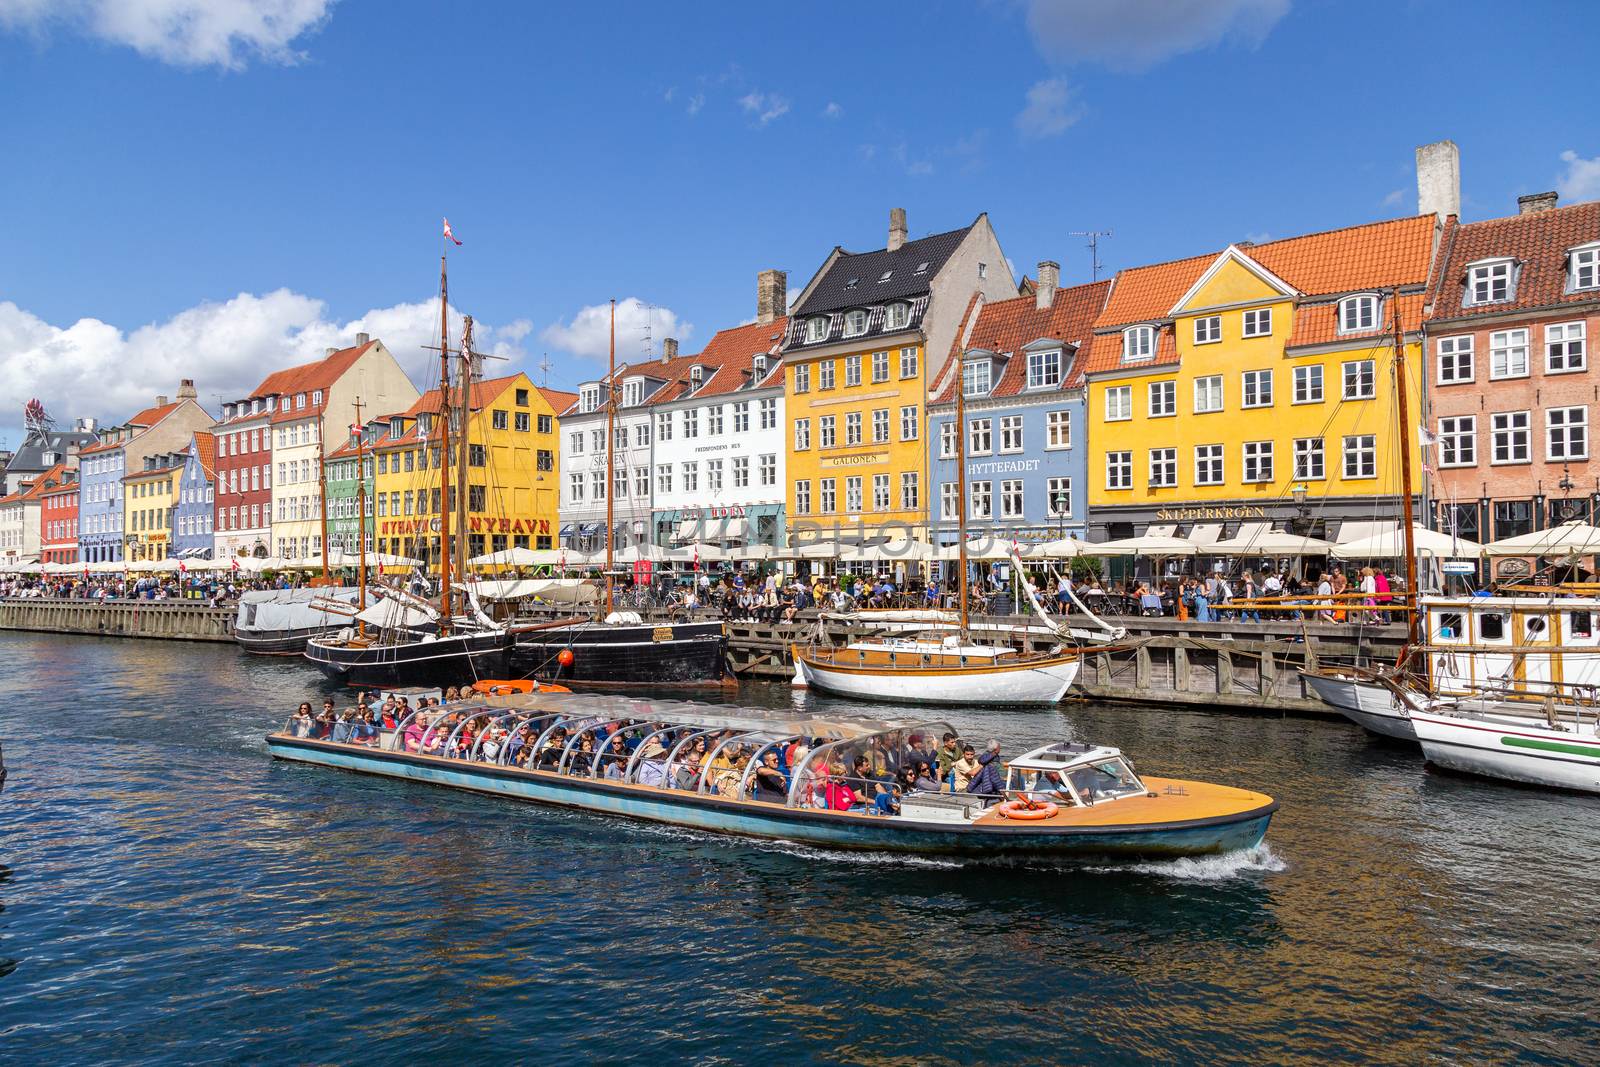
[1430,200,1600,320]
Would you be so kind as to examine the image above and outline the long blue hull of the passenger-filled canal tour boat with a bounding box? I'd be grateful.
[267,734,1277,859]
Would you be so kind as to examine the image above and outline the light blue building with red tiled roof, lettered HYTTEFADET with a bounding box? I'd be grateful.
[928,262,1110,544]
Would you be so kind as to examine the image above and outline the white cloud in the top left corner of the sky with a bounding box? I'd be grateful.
[0,0,333,70]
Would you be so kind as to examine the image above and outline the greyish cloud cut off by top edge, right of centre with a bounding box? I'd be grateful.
[1027,0,1290,70]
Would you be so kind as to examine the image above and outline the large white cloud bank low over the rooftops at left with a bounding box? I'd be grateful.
[0,290,533,435]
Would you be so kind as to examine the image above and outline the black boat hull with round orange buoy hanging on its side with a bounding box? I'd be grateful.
[512,622,728,686]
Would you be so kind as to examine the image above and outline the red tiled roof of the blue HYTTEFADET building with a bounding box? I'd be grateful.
[934,280,1110,403]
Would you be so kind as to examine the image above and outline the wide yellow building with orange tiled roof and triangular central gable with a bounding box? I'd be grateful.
[1086,214,1437,542]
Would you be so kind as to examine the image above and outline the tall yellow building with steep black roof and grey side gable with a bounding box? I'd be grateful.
[784,210,1016,541]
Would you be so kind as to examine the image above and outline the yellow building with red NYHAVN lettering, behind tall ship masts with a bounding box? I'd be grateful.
[373,374,576,569]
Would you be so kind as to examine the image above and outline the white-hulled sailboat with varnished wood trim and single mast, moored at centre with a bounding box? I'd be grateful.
[790,337,1082,705]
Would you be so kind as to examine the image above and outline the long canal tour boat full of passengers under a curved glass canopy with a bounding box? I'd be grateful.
[266,694,1277,861]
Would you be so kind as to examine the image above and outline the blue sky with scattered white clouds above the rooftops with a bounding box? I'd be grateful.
[0,0,1600,446]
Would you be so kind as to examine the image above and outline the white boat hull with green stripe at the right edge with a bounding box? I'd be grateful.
[1411,712,1600,793]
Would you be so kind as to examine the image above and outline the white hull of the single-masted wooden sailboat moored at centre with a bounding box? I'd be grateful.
[794,649,1080,705]
